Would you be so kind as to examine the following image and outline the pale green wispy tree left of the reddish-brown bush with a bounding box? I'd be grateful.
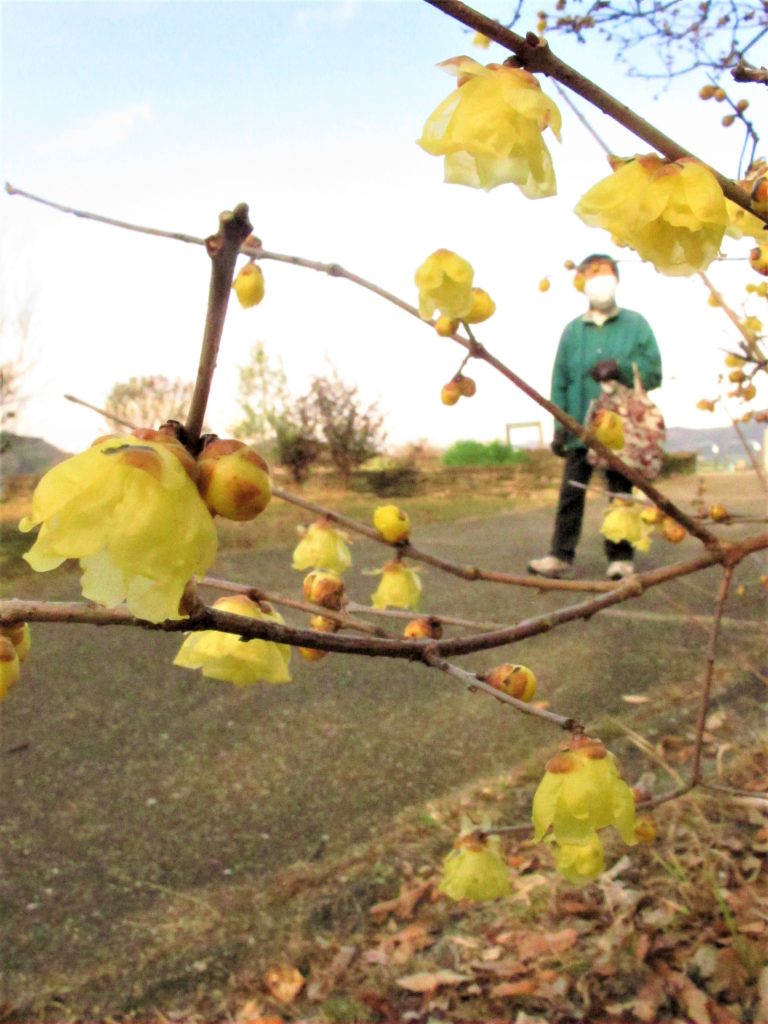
[231,341,290,444]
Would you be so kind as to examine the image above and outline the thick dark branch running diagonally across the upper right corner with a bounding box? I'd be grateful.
[426,0,755,213]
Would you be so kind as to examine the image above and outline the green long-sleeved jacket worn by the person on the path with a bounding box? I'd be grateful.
[552,309,662,449]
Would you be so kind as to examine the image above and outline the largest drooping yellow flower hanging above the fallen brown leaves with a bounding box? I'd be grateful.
[532,736,636,846]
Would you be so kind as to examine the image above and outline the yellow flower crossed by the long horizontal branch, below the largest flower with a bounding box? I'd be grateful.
[173,594,291,686]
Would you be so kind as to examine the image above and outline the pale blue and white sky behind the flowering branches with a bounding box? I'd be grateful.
[0,0,766,446]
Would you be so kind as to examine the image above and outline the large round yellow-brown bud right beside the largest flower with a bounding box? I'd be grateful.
[198,440,272,522]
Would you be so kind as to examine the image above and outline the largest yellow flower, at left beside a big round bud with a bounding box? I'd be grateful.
[19,436,216,623]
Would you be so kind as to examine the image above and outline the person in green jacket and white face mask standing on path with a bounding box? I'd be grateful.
[528,253,662,580]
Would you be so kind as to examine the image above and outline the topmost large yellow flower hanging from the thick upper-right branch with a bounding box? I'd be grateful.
[419,56,560,199]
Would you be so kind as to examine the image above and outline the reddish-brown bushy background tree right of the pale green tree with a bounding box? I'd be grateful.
[308,370,386,482]
